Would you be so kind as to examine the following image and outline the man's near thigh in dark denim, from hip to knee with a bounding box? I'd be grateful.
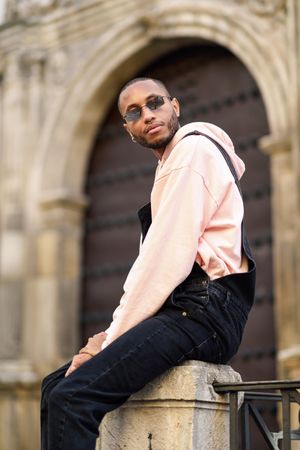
[51,310,215,409]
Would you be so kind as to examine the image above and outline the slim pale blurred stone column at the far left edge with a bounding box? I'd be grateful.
[0,57,28,371]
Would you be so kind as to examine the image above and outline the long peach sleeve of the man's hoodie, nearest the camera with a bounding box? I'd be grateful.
[102,166,217,349]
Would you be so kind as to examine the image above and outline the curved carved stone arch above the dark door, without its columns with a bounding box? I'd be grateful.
[34,2,288,204]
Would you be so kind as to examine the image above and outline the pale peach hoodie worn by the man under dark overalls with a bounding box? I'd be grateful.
[102,122,247,349]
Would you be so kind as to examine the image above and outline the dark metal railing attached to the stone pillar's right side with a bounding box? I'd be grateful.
[214,380,300,450]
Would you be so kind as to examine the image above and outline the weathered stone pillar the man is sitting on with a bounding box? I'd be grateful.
[96,361,241,450]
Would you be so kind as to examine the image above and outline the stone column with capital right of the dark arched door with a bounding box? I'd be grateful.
[260,135,300,379]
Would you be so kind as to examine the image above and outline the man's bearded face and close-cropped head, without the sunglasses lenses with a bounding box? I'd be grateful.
[119,80,179,149]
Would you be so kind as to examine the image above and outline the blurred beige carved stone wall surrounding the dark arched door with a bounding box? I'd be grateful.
[0,0,300,450]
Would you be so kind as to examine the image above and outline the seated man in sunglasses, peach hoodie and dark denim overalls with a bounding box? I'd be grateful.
[41,78,255,450]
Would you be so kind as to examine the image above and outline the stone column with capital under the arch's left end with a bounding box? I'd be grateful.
[23,191,86,376]
